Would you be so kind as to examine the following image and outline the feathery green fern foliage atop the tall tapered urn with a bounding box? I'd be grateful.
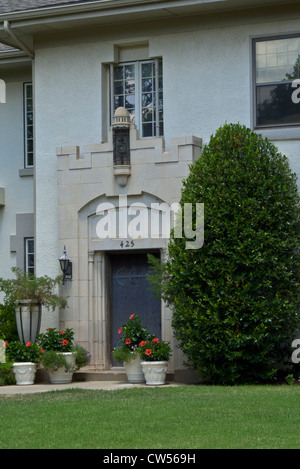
[0,267,67,310]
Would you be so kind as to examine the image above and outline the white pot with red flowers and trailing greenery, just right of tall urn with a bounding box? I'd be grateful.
[37,328,90,384]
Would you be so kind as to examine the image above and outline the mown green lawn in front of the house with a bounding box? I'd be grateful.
[0,385,300,450]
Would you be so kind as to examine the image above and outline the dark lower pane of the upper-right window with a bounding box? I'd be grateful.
[256,83,300,126]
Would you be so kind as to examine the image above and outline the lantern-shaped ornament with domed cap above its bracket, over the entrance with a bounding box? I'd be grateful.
[112,107,130,166]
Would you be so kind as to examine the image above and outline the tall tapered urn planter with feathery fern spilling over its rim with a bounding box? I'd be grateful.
[0,267,67,344]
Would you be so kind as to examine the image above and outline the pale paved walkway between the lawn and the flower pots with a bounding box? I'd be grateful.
[0,380,177,399]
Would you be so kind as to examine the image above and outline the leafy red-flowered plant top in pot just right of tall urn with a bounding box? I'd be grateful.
[36,327,74,352]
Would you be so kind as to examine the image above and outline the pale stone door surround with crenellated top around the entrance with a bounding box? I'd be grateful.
[57,122,201,371]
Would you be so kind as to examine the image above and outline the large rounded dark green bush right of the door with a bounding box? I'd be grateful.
[158,124,300,384]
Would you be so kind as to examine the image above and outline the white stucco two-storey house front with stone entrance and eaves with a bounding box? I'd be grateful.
[0,0,300,379]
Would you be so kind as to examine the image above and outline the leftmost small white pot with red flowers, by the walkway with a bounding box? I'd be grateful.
[5,341,41,385]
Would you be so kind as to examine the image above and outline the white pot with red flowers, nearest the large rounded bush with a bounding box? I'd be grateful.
[139,338,172,386]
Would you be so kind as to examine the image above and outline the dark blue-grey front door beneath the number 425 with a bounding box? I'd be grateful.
[111,253,161,364]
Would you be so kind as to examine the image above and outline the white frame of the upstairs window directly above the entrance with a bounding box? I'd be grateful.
[110,58,164,138]
